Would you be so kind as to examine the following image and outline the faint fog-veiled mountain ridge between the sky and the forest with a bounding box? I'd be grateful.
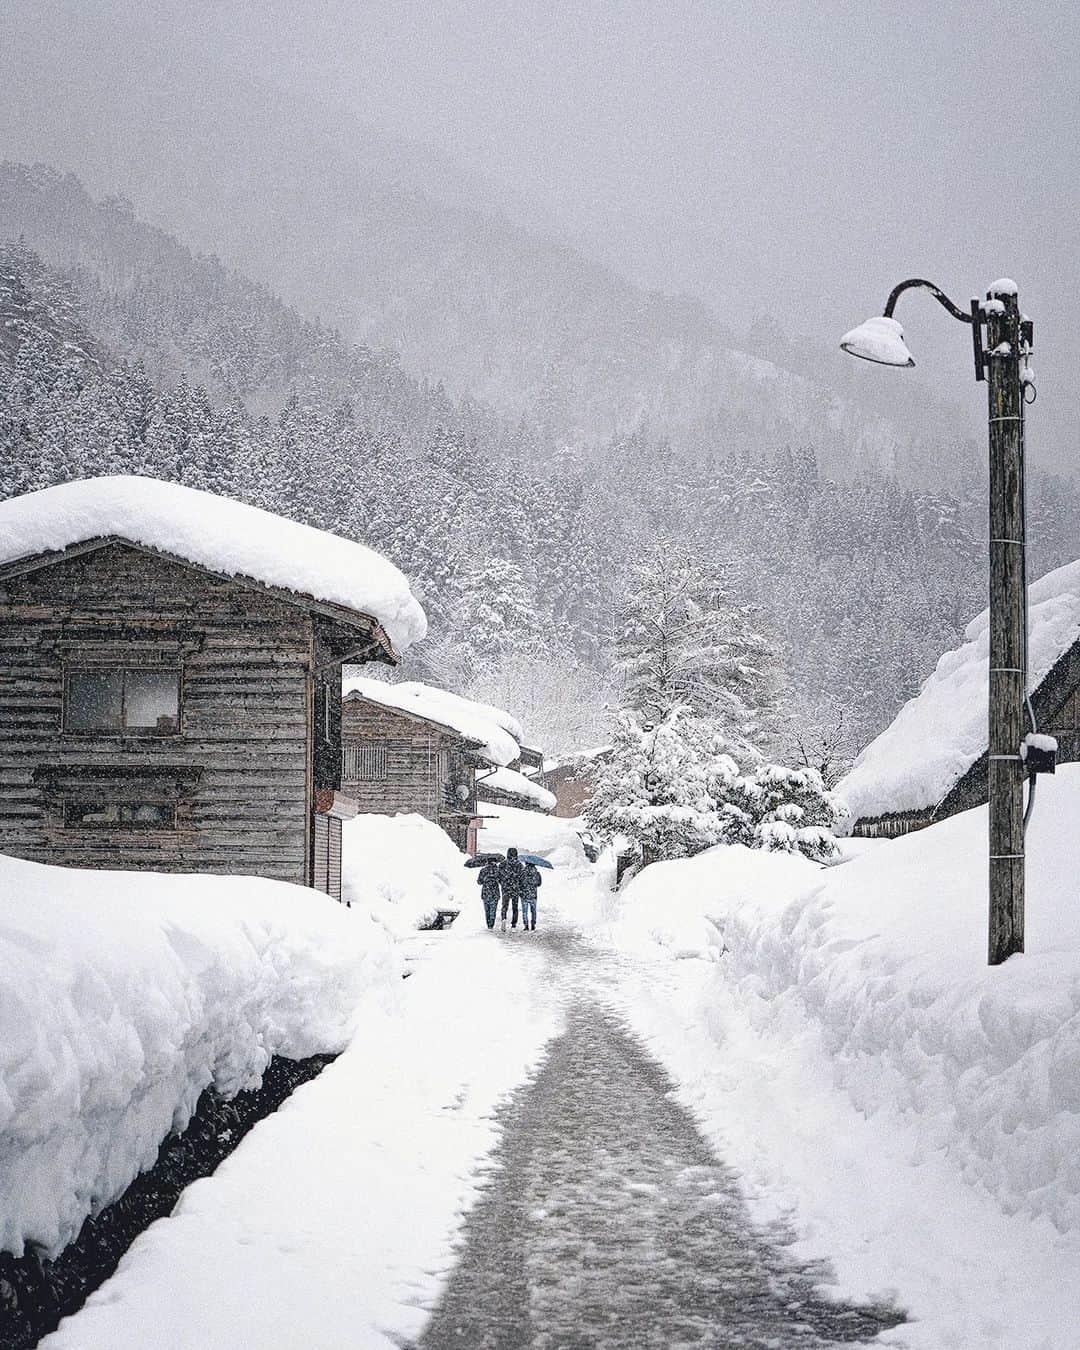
[0,159,969,481]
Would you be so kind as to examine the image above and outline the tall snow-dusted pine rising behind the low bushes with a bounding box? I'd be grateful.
[616,545,780,756]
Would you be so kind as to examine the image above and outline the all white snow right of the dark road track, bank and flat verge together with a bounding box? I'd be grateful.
[606,765,1080,1350]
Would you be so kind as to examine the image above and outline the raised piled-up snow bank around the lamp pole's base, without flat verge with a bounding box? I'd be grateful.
[614,764,1080,1234]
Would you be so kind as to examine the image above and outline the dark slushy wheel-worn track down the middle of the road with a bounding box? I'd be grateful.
[419,915,900,1350]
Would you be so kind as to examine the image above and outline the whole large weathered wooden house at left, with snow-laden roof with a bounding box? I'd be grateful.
[0,479,423,895]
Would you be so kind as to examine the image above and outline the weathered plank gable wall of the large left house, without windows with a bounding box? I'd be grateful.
[0,544,315,883]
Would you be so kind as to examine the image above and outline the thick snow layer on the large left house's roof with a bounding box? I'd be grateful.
[0,477,428,651]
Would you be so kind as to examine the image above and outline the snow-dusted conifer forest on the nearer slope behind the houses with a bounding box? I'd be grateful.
[0,193,1080,749]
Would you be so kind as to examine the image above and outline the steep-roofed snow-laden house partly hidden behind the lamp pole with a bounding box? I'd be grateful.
[836,562,1080,838]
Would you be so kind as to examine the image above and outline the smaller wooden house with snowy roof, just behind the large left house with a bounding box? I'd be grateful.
[342,676,540,853]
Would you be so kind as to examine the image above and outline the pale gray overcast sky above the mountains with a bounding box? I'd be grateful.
[0,0,1080,467]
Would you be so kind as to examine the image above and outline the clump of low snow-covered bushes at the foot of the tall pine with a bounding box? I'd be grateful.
[585,709,838,863]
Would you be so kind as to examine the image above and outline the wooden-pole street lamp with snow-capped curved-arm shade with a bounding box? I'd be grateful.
[840,278,1036,965]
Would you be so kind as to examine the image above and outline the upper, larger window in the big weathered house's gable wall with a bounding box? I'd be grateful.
[63,668,180,736]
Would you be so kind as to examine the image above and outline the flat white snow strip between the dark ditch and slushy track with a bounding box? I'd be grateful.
[42,873,562,1350]
